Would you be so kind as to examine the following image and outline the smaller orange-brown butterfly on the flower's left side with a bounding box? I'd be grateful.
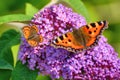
[22,25,43,47]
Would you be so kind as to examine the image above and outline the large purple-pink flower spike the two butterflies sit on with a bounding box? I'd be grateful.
[19,4,120,80]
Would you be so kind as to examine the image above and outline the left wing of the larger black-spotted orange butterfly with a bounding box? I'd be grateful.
[51,32,84,52]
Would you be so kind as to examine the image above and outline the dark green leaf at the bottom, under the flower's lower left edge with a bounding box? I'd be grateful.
[12,61,38,80]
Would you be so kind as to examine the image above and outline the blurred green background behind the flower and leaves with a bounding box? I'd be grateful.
[0,0,120,80]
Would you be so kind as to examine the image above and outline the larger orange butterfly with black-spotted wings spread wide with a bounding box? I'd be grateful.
[51,21,108,52]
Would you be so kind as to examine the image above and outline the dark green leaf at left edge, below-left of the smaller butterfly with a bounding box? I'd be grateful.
[0,30,20,66]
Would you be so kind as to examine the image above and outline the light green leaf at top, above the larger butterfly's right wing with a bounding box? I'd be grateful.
[62,0,90,22]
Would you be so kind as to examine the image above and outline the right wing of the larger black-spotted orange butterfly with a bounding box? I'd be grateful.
[79,21,108,47]
